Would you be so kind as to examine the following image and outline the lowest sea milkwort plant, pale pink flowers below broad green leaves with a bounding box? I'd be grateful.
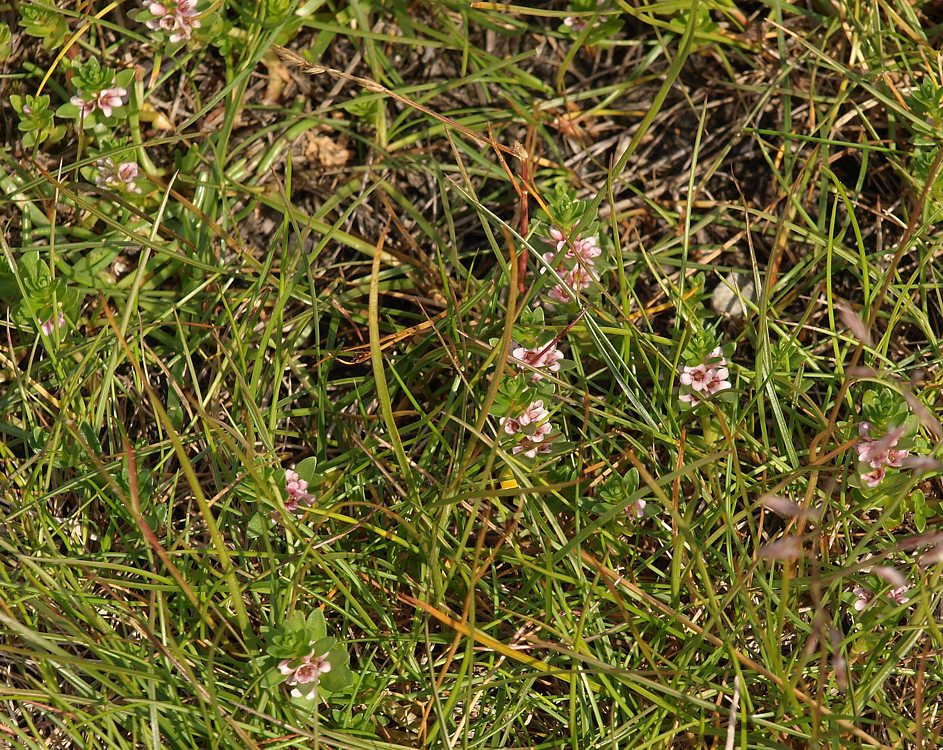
[262,609,353,701]
